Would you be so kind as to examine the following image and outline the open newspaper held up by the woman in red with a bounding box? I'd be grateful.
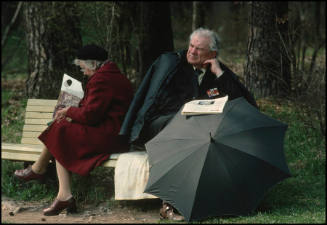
[48,74,84,125]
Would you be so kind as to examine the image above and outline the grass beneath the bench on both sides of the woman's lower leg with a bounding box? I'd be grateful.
[1,160,114,204]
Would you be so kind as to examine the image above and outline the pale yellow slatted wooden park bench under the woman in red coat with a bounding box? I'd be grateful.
[1,99,119,167]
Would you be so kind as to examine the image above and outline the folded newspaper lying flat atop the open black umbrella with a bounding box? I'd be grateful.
[181,95,228,115]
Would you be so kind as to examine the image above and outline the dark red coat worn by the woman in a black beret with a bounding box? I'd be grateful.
[39,62,133,176]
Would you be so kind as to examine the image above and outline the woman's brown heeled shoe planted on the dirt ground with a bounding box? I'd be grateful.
[43,197,76,216]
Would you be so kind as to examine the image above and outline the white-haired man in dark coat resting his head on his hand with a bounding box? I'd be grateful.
[120,28,257,219]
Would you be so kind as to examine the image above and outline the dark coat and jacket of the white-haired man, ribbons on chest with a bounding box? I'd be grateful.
[119,50,258,143]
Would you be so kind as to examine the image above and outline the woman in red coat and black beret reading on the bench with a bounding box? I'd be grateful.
[15,45,133,216]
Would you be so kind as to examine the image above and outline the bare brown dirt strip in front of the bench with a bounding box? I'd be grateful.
[1,197,172,224]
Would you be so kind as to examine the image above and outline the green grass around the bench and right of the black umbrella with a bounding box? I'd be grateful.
[1,82,326,223]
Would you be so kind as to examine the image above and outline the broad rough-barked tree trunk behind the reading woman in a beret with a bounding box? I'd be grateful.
[24,2,82,99]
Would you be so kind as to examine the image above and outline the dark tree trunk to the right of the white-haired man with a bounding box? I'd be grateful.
[244,1,290,97]
